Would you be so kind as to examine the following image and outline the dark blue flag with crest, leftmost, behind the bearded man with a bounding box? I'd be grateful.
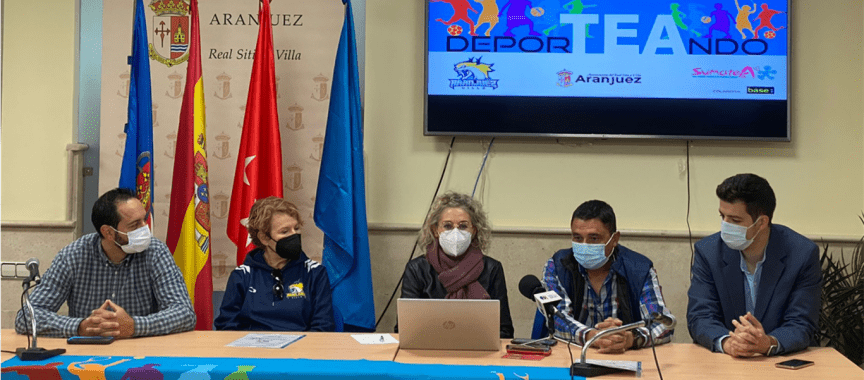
[119,0,153,227]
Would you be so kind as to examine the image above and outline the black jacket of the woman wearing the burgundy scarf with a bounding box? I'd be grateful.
[395,255,513,339]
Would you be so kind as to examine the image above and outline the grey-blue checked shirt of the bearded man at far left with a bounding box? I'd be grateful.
[15,233,195,337]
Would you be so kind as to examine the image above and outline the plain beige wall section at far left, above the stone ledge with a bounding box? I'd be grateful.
[0,0,75,221]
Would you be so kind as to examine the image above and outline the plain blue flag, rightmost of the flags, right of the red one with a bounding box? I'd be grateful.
[315,0,375,331]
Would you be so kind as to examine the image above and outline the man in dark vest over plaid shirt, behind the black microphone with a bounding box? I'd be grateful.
[543,200,673,353]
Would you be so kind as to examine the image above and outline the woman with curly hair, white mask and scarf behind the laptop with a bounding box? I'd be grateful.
[401,192,513,338]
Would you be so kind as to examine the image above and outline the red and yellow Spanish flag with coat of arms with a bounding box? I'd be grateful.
[167,0,213,330]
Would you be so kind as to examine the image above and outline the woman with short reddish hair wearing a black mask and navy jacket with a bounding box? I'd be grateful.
[213,197,335,331]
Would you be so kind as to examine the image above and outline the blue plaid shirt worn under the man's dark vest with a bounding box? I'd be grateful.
[543,255,674,348]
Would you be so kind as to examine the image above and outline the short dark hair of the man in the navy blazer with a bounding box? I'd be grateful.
[717,173,777,222]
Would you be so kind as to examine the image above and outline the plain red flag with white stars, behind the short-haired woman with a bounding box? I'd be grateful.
[227,0,282,265]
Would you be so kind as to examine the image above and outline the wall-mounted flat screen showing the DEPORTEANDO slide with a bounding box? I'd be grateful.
[424,0,790,141]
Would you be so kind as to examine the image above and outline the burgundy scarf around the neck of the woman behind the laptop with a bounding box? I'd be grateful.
[426,241,490,299]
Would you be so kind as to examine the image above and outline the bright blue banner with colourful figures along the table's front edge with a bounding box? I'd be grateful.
[0,355,581,380]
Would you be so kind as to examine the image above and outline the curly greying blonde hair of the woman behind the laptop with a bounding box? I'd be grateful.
[420,191,492,251]
